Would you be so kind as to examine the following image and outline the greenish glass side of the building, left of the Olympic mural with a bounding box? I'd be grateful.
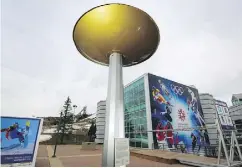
[124,75,149,148]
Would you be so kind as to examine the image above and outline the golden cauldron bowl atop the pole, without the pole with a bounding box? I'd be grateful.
[73,3,160,67]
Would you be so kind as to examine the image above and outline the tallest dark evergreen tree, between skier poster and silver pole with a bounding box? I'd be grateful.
[60,96,74,143]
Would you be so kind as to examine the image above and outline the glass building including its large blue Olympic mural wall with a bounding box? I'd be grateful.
[124,73,209,152]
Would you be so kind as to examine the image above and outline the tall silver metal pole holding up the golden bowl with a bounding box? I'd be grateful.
[102,53,125,167]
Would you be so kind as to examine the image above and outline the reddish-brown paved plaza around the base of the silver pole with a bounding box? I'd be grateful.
[36,145,187,167]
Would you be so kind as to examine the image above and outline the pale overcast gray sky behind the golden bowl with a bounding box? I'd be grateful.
[1,0,242,116]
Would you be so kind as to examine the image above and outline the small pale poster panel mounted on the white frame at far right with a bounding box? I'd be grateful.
[215,100,234,130]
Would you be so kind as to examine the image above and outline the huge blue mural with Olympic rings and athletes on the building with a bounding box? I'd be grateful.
[149,74,209,153]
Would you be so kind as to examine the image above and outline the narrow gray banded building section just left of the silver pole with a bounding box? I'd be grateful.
[95,101,106,144]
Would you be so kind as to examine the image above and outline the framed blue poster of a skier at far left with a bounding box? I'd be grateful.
[1,117,41,164]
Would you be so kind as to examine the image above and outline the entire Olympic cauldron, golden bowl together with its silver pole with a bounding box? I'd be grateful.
[73,3,160,167]
